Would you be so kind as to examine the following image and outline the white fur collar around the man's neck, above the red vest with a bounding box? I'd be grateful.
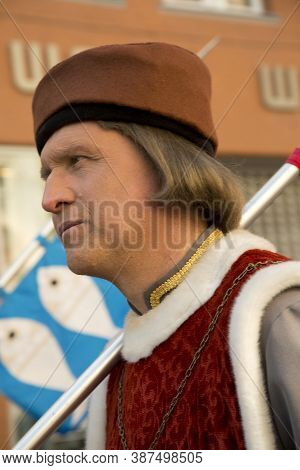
[121,229,276,362]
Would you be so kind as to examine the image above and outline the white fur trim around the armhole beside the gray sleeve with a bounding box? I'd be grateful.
[229,261,300,450]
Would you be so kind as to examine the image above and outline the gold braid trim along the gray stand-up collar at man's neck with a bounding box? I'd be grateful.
[150,228,224,308]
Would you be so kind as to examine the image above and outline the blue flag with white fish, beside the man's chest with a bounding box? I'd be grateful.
[0,232,129,433]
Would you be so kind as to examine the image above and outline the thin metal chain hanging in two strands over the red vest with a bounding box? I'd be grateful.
[118,260,283,450]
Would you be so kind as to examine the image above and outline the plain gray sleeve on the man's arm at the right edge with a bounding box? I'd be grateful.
[261,286,300,449]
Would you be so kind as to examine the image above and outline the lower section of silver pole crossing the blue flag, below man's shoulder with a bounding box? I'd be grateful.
[13,332,124,450]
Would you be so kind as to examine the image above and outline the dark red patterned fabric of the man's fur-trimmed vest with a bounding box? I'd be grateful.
[106,250,289,450]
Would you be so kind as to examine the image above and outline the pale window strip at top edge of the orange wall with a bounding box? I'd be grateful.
[162,0,264,15]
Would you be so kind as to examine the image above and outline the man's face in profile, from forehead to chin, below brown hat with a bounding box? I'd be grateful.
[41,121,158,280]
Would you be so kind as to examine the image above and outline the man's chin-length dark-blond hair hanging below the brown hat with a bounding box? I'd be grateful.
[97,121,245,233]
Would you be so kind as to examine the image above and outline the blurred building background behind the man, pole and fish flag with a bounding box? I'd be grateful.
[0,0,300,449]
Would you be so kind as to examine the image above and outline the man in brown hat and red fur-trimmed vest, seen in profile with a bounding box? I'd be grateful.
[33,42,300,449]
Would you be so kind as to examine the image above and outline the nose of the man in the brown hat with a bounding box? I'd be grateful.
[42,168,75,214]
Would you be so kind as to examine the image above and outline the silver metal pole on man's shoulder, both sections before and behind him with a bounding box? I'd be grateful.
[13,149,300,450]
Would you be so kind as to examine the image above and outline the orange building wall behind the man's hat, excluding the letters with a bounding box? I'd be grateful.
[0,0,300,155]
